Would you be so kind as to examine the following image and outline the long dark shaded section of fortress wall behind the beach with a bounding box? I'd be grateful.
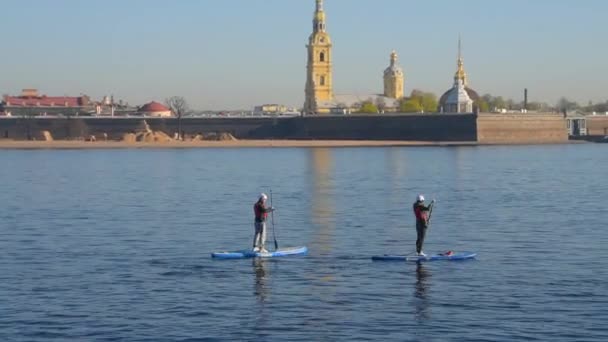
[0,114,476,141]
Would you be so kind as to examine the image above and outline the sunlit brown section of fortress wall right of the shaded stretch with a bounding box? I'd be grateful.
[477,113,568,144]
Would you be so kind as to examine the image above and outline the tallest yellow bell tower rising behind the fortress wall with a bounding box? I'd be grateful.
[304,0,334,115]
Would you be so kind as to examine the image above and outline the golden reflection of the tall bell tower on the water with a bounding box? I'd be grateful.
[309,148,335,253]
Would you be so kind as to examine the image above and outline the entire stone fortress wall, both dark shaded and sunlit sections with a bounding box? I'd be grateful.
[0,114,568,144]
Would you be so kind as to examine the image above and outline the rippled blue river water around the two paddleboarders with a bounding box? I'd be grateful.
[0,144,608,341]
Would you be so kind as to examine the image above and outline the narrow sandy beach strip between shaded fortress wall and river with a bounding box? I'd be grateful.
[0,140,477,149]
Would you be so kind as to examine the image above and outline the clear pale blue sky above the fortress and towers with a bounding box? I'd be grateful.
[0,0,608,109]
